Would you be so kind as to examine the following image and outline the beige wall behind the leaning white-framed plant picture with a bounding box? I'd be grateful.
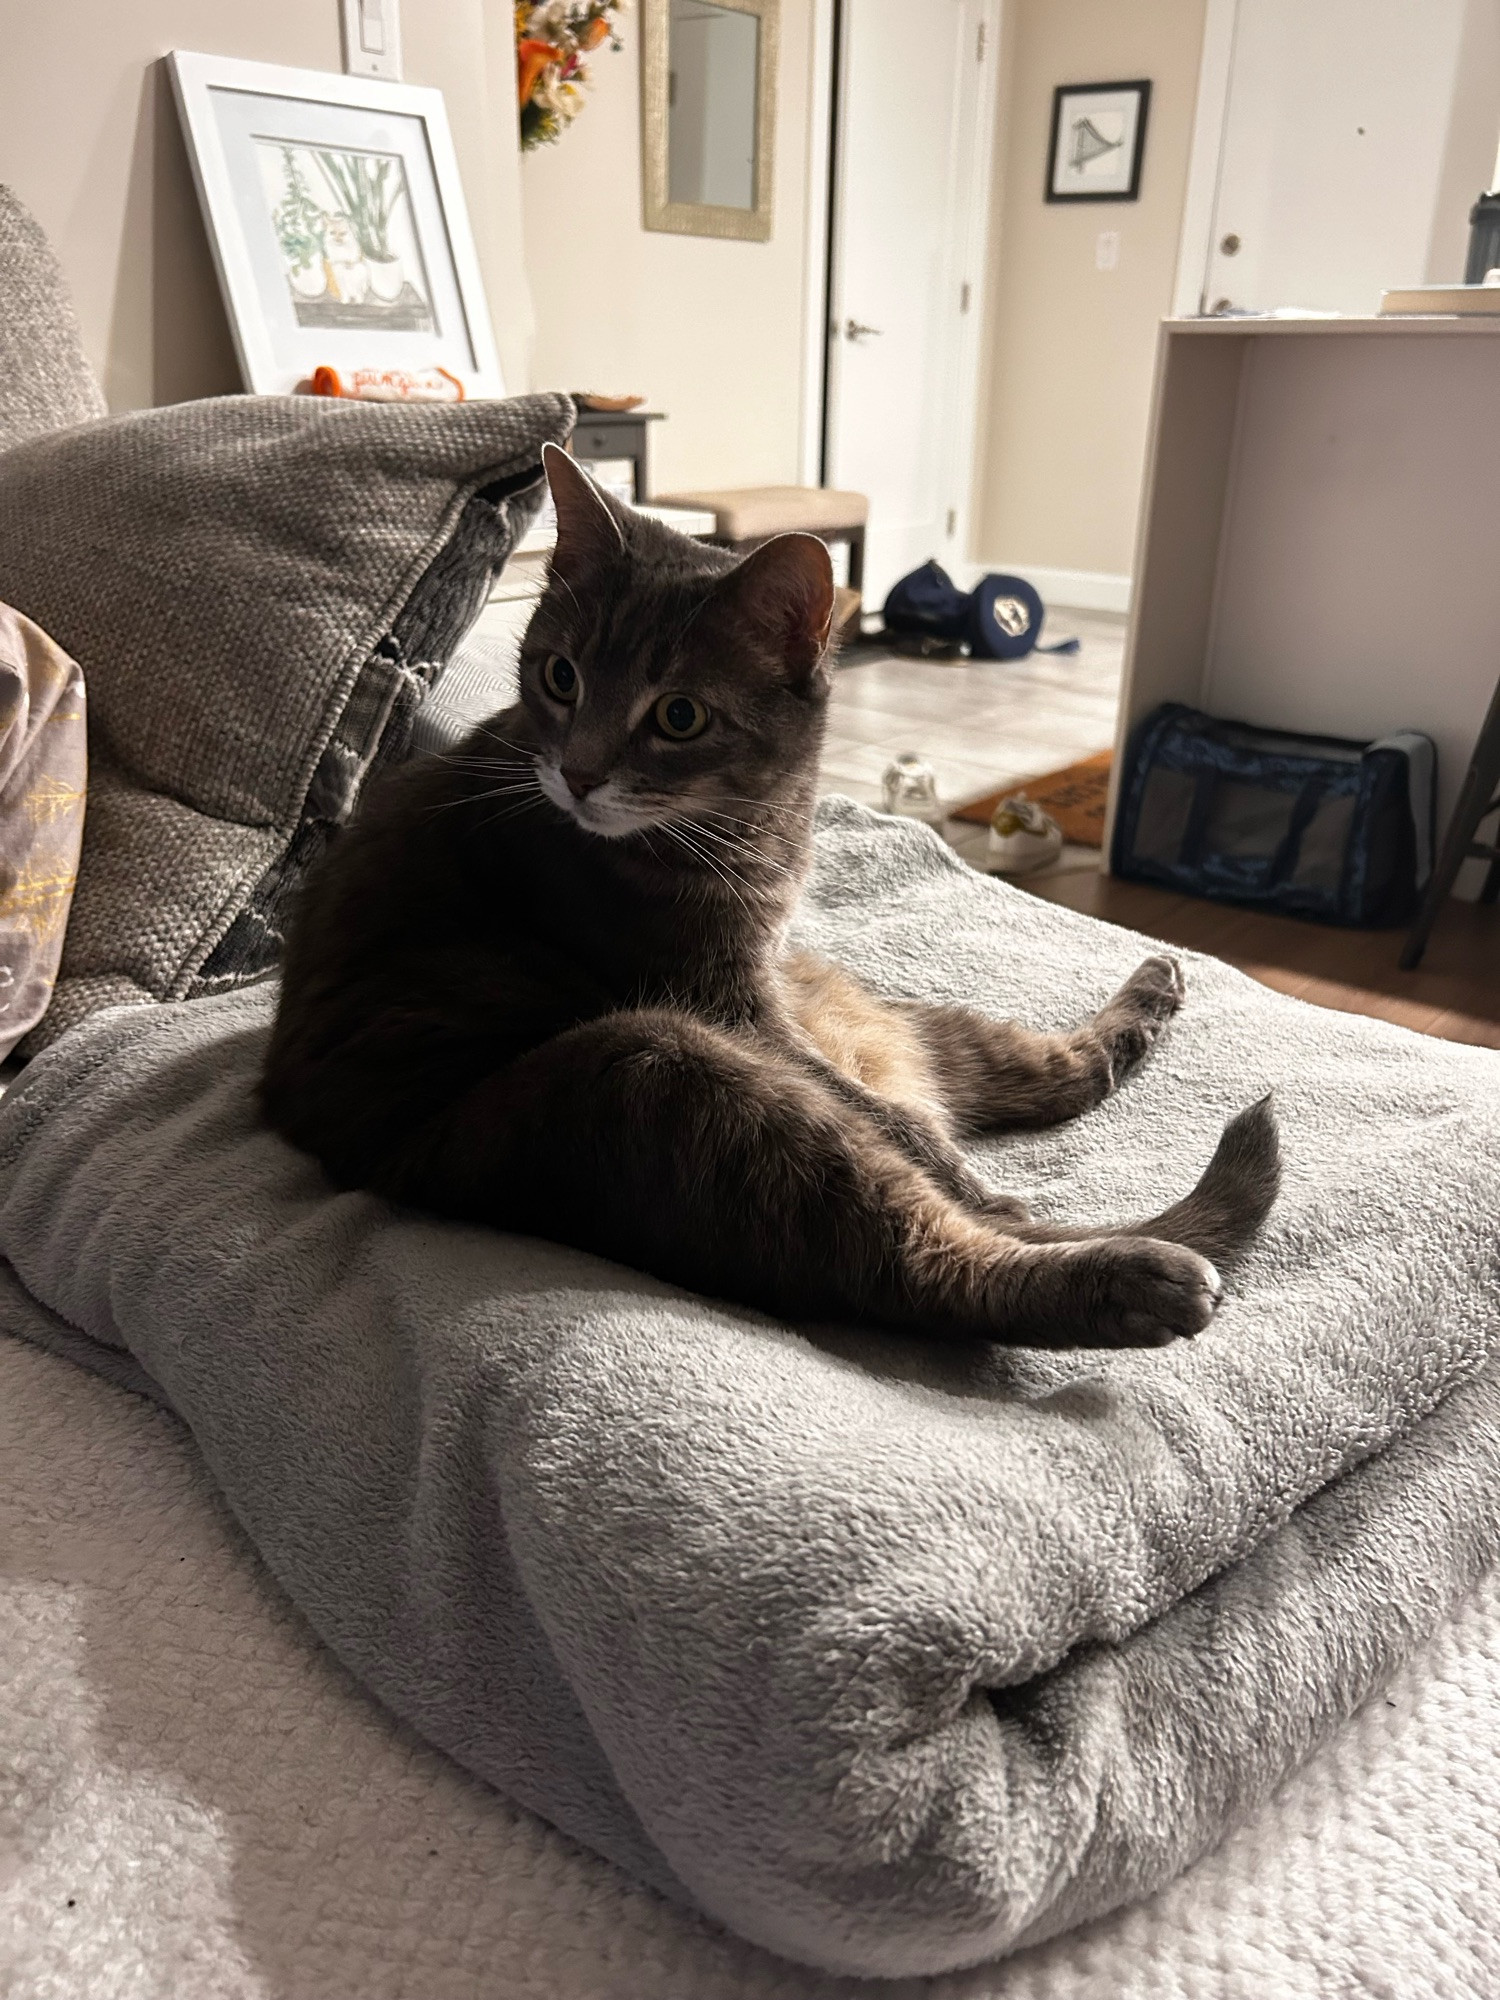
[0,0,530,410]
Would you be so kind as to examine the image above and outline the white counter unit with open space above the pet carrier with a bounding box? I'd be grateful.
[1104,318,1500,892]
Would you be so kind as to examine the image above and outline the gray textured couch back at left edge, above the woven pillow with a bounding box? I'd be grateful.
[0,188,104,450]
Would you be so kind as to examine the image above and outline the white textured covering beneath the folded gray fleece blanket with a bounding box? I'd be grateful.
[0,1338,1500,2000]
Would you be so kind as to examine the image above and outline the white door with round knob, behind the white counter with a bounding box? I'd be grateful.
[1194,0,1494,314]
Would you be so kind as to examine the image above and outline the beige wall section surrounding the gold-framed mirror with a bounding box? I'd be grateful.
[520,0,814,492]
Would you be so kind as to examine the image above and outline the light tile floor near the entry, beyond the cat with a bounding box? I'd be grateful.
[822,610,1124,868]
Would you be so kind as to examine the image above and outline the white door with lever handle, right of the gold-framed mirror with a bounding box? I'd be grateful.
[824,0,998,606]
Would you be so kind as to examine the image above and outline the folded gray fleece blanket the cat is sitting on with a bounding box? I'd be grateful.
[0,802,1500,1974]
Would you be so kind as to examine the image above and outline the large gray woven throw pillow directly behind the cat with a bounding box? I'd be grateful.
[0,394,574,1054]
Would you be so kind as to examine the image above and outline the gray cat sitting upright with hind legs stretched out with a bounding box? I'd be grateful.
[264,446,1280,1346]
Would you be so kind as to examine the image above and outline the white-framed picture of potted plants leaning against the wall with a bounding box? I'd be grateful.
[170,50,504,396]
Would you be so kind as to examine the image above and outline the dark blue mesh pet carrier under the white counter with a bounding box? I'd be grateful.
[1112,702,1436,926]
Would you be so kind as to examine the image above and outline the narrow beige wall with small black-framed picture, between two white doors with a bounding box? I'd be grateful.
[974,0,1204,592]
